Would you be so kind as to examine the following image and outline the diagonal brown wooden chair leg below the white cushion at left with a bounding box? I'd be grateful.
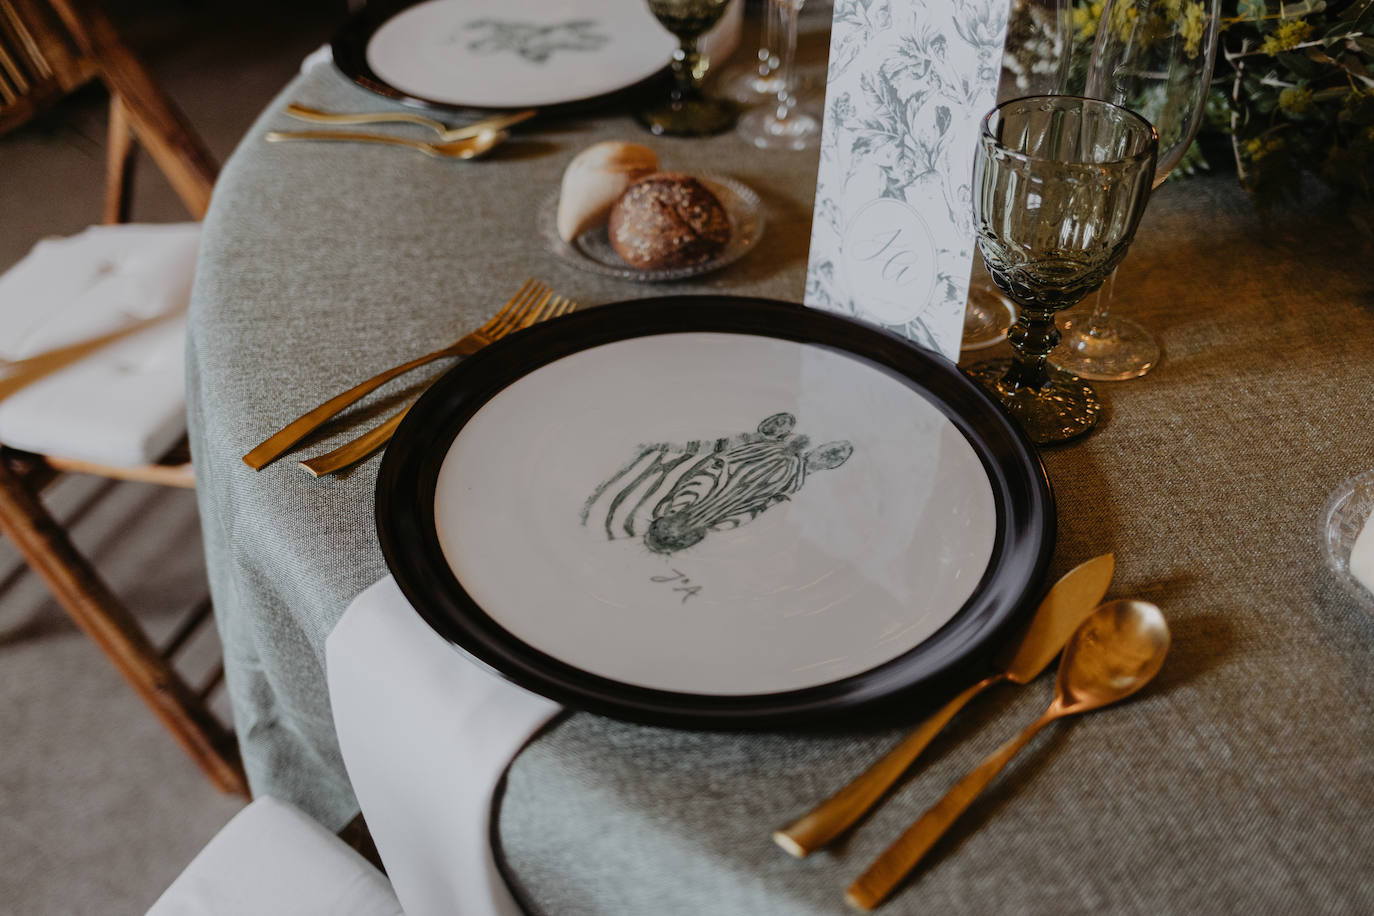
[0,461,249,797]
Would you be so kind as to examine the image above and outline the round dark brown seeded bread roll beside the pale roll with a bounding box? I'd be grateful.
[610,172,730,271]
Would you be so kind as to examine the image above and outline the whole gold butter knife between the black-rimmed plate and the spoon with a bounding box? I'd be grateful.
[774,553,1116,858]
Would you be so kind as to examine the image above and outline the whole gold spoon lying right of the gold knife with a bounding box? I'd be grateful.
[845,600,1169,911]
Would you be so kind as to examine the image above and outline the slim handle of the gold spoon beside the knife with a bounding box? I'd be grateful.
[845,707,1059,911]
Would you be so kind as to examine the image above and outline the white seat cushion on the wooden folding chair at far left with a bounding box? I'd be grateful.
[0,222,201,466]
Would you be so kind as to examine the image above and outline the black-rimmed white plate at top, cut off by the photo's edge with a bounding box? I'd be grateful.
[331,0,676,117]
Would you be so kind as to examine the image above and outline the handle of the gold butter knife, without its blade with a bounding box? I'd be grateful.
[774,674,1006,858]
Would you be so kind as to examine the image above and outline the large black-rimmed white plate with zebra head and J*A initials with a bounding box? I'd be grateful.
[376,297,1055,726]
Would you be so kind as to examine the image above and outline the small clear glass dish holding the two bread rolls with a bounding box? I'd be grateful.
[539,173,764,283]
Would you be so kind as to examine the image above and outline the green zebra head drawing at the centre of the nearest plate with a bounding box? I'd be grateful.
[583,413,853,553]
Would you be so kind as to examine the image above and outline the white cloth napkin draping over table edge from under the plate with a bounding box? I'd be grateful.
[326,575,559,916]
